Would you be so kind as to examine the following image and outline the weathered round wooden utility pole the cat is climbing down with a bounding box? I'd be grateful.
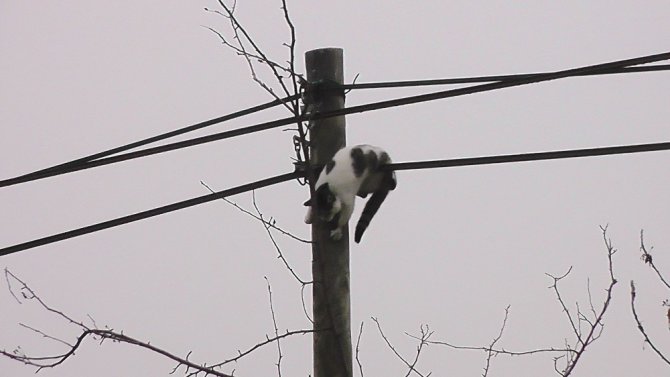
[305,48,353,377]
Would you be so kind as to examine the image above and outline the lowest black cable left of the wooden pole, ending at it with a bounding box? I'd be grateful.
[0,172,299,256]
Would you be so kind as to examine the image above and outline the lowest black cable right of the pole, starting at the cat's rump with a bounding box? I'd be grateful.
[383,142,670,171]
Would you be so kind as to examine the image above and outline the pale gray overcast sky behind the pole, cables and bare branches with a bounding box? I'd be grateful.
[0,0,670,377]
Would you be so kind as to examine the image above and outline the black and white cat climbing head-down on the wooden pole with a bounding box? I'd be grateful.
[305,145,397,243]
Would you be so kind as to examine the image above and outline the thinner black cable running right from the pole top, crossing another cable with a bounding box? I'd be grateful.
[338,64,670,90]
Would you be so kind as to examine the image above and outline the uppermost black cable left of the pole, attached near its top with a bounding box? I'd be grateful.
[0,94,300,187]
